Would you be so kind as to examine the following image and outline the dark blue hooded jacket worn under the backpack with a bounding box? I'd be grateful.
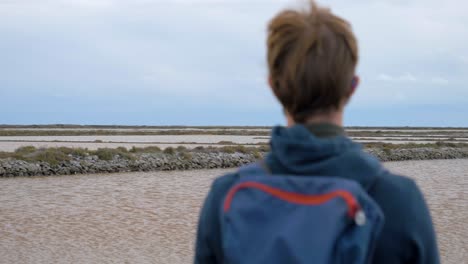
[195,125,439,264]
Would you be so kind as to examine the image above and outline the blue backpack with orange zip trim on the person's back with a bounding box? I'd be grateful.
[221,163,384,264]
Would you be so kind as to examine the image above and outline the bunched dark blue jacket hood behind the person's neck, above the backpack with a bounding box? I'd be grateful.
[266,125,386,189]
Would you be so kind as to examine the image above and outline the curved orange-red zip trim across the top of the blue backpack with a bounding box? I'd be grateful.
[224,181,360,218]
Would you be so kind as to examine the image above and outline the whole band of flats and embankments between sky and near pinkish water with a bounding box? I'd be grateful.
[0,125,468,177]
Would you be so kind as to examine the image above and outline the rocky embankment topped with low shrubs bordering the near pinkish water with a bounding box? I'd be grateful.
[0,142,468,177]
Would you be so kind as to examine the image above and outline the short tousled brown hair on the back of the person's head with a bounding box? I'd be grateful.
[267,1,358,123]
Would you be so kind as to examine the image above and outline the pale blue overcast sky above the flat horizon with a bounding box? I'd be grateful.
[0,0,468,126]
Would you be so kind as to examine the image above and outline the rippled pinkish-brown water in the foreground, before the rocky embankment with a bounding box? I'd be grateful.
[0,160,468,263]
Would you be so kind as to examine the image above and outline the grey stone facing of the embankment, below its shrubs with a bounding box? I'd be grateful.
[0,147,468,178]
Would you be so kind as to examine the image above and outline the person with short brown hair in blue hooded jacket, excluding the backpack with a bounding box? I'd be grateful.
[195,2,439,264]
